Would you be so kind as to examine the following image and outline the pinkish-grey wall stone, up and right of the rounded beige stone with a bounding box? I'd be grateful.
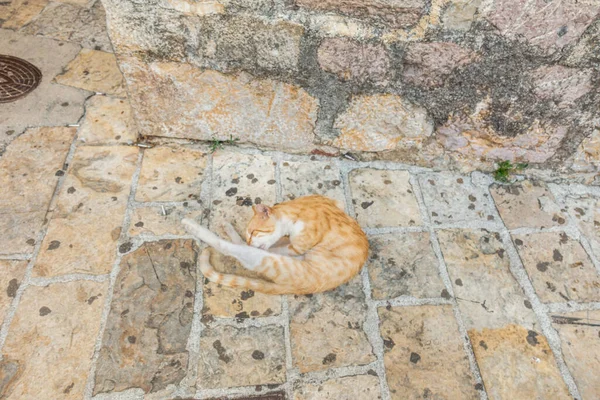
[402,42,475,87]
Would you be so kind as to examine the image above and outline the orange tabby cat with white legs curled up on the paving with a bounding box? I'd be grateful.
[182,195,369,294]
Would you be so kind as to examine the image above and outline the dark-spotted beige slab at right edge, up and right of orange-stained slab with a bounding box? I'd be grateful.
[513,232,600,303]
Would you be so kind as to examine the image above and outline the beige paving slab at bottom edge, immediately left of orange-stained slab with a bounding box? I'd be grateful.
[378,306,479,399]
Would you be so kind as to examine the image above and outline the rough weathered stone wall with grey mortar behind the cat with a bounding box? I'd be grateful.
[103,0,600,173]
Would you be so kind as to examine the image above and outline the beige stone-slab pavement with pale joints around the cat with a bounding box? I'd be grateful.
[0,0,600,400]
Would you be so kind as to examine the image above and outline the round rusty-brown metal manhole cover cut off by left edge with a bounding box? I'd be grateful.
[0,55,42,103]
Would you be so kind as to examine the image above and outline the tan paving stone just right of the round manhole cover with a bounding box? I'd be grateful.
[54,49,126,97]
